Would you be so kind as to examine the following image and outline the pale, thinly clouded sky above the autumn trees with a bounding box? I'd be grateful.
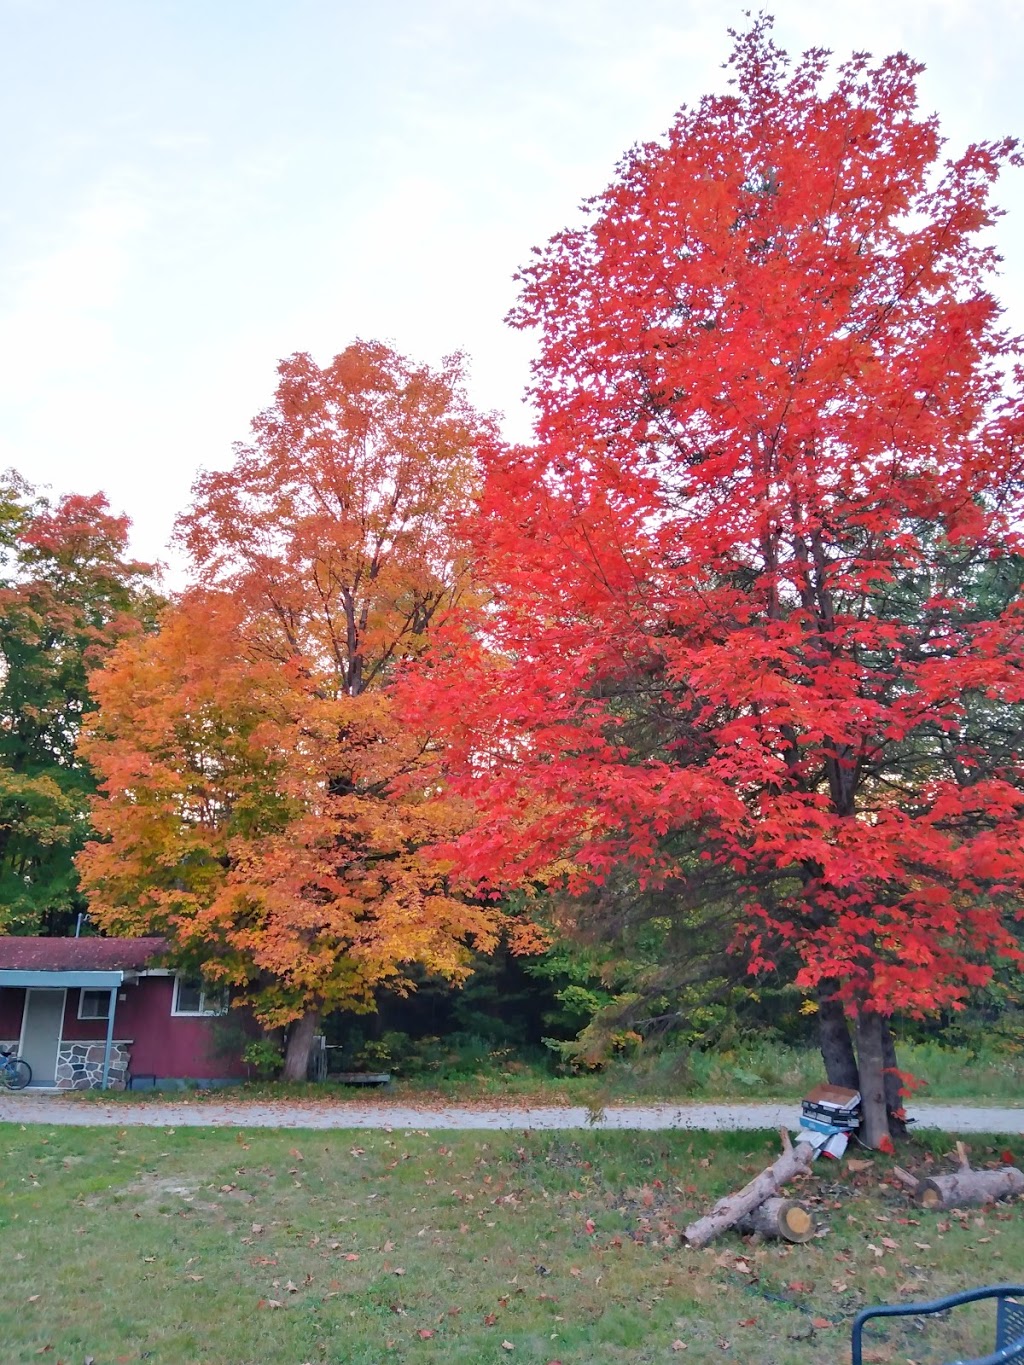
[0,0,1024,577]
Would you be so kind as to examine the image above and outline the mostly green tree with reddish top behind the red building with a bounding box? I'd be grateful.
[0,471,160,934]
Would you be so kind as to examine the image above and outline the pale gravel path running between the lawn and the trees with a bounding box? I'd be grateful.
[0,1093,1024,1133]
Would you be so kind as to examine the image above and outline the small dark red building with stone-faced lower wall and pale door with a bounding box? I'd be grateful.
[0,936,247,1091]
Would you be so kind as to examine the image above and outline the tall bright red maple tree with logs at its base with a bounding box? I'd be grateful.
[418,26,1024,1144]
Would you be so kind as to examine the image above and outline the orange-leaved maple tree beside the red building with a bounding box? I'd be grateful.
[82,341,494,1078]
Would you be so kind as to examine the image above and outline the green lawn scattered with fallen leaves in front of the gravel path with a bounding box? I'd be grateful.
[0,1125,1024,1365]
